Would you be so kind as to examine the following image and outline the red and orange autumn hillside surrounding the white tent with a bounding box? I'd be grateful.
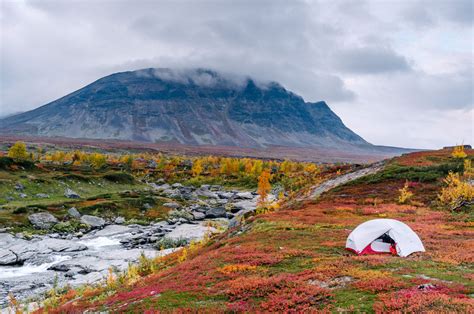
[31,150,474,313]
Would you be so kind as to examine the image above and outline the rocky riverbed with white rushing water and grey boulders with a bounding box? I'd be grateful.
[0,183,270,308]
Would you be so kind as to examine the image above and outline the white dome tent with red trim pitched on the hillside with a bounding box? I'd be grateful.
[346,219,425,257]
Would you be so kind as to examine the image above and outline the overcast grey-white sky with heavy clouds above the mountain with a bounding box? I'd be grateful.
[0,0,474,148]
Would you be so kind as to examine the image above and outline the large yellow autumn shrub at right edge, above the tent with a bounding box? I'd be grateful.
[438,172,474,211]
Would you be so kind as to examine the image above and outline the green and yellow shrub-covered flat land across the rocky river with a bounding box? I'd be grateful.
[0,142,334,234]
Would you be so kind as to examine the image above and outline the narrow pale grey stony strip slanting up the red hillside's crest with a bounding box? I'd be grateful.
[298,162,384,201]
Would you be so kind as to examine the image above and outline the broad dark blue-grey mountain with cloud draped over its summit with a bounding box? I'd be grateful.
[0,69,373,149]
